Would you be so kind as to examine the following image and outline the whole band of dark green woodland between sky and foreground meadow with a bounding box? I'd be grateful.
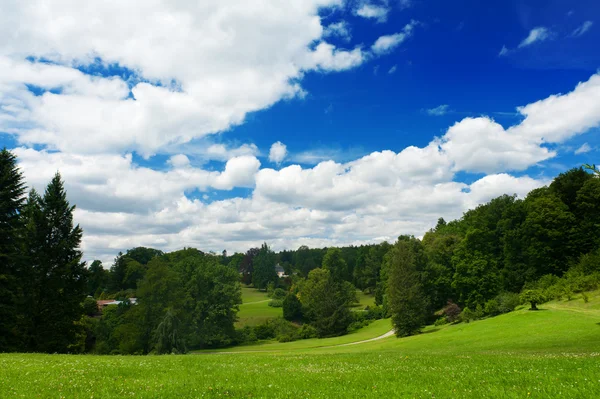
[0,150,600,354]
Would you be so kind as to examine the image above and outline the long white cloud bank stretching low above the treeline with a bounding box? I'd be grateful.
[15,67,600,261]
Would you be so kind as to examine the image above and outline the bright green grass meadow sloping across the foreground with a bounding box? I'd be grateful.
[0,293,600,398]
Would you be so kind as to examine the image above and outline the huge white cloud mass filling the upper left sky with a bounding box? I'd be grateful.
[0,0,366,156]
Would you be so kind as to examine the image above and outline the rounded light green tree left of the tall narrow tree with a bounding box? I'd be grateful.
[299,268,352,337]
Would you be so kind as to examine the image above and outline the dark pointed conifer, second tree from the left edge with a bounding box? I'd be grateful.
[25,173,87,352]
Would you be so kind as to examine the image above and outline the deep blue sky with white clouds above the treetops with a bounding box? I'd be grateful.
[0,0,600,267]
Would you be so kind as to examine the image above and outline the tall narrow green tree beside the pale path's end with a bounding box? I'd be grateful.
[387,240,427,337]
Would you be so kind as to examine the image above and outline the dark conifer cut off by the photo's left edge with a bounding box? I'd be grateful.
[0,148,25,352]
